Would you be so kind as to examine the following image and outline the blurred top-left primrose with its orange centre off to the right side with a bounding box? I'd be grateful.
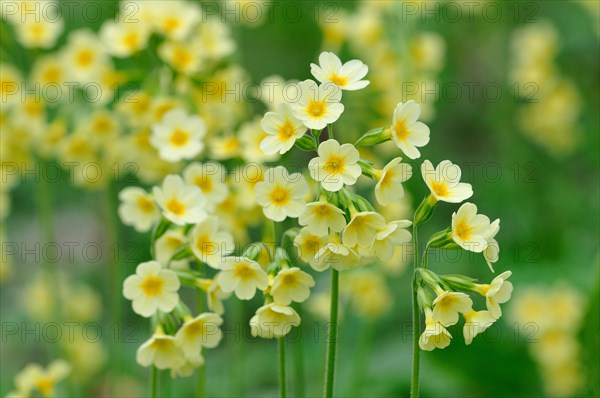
[100,20,150,57]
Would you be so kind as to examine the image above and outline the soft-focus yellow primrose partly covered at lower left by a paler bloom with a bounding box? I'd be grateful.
[183,162,229,210]
